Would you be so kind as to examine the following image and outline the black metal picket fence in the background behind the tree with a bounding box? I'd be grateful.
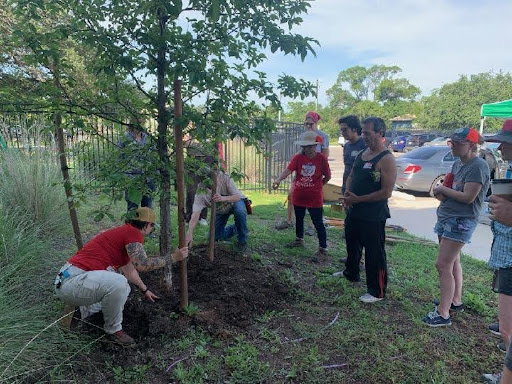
[0,113,304,192]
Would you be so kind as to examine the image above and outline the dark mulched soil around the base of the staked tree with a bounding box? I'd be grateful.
[75,244,293,383]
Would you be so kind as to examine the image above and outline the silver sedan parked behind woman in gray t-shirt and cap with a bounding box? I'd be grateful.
[396,145,455,195]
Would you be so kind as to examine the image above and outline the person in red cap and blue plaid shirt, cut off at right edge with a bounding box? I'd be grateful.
[483,119,512,383]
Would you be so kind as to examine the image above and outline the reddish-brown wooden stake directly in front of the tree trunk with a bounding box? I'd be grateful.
[174,80,188,309]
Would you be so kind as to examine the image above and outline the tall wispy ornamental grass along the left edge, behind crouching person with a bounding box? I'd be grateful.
[0,149,85,383]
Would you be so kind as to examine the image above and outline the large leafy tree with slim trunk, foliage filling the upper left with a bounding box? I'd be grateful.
[3,0,317,256]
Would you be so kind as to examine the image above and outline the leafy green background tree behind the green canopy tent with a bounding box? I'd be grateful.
[419,72,512,131]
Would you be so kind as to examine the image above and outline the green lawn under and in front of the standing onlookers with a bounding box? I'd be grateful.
[162,192,503,383]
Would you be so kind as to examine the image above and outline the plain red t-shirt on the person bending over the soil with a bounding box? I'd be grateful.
[68,224,144,271]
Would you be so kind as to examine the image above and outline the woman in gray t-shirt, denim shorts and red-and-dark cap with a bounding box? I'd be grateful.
[422,128,490,327]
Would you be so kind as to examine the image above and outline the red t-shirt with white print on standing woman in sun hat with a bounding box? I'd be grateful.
[288,153,331,208]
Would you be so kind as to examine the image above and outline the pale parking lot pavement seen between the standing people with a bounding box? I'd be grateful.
[329,145,492,261]
